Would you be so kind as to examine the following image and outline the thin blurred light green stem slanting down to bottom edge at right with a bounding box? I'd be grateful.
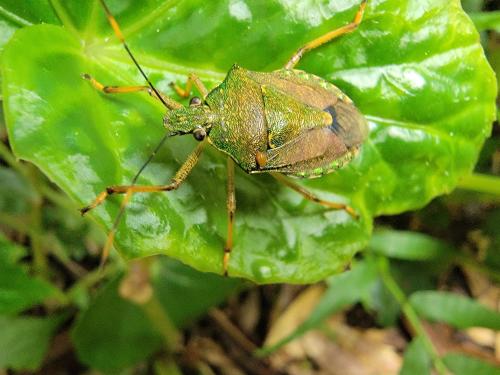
[377,257,448,375]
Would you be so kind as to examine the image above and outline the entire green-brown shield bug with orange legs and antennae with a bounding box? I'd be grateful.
[81,0,367,275]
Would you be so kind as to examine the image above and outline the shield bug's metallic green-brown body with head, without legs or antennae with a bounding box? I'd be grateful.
[164,65,367,178]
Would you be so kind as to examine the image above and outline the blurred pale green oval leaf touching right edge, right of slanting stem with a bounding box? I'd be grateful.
[410,291,500,330]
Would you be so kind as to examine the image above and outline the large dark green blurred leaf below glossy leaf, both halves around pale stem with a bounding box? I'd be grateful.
[72,258,241,371]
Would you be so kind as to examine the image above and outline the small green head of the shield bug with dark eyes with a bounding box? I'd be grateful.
[163,97,217,141]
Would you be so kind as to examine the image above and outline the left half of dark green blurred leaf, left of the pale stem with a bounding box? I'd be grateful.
[71,279,161,371]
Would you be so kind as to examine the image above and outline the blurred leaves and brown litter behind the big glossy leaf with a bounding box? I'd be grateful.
[0,0,500,374]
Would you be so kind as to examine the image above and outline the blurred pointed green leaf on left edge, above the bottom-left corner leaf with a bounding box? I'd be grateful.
[0,236,57,314]
